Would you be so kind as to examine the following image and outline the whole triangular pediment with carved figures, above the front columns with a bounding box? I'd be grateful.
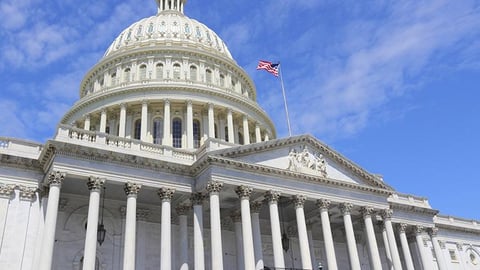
[210,135,392,189]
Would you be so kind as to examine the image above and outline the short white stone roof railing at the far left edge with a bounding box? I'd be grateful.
[0,137,43,159]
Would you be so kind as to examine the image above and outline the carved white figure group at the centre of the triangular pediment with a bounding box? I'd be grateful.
[287,146,327,177]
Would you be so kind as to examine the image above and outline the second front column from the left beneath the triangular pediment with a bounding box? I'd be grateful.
[235,186,255,270]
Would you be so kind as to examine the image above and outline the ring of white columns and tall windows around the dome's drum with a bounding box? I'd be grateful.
[83,99,270,149]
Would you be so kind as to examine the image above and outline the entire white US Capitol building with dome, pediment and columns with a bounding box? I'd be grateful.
[0,0,480,270]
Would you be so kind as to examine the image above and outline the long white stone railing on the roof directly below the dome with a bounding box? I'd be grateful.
[55,125,197,162]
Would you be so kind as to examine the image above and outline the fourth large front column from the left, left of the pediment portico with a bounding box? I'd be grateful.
[157,188,175,270]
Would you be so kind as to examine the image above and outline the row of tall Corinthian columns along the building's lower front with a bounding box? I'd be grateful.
[34,172,447,270]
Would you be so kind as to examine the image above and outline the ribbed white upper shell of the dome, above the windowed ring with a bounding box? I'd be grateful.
[105,10,233,60]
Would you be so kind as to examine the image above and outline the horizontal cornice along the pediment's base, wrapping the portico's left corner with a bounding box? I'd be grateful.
[192,155,391,196]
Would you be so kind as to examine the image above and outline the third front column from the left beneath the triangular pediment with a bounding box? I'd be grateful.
[265,190,285,269]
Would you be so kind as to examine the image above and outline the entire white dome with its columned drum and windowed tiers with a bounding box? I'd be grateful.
[61,0,275,152]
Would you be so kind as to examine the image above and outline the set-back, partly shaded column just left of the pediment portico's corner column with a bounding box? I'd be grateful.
[190,192,205,270]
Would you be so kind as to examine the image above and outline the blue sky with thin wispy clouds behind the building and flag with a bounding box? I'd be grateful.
[0,0,480,220]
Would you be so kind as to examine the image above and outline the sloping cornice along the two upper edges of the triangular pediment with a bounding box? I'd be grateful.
[208,134,393,191]
